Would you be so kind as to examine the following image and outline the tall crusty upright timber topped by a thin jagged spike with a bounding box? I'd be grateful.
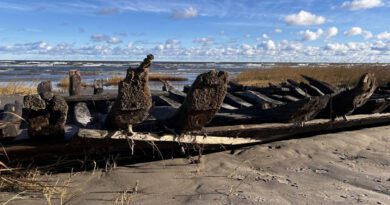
[106,54,154,129]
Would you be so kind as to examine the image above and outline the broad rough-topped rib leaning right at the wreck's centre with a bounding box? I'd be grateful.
[166,70,228,132]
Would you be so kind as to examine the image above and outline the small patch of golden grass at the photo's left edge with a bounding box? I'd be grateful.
[0,82,37,95]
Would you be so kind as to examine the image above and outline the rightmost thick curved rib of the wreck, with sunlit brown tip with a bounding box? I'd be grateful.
[319,73,377,120]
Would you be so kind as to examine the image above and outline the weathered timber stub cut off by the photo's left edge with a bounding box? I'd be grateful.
[0,100,23,138]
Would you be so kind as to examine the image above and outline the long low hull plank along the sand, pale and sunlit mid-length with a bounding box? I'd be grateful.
[4,113,390,161]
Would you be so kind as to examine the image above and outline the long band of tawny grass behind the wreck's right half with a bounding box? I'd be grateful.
[235,64,390,87]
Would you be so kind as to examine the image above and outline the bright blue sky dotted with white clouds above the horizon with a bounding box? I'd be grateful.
[0,0,390,62]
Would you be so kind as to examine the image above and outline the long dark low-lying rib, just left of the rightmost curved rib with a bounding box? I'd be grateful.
[210,95,330,126]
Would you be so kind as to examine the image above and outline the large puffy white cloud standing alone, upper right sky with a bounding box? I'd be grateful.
[284,10,325,26]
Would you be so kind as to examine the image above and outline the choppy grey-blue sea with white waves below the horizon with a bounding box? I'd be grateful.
[0,60,380,90]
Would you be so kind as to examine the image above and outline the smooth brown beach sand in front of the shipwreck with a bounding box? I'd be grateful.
[0,126,390,205]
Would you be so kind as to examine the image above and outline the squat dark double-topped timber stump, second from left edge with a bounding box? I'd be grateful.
[23,85,68,138]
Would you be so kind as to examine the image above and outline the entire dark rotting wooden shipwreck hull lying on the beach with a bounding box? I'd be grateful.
[0,60,390,162]
